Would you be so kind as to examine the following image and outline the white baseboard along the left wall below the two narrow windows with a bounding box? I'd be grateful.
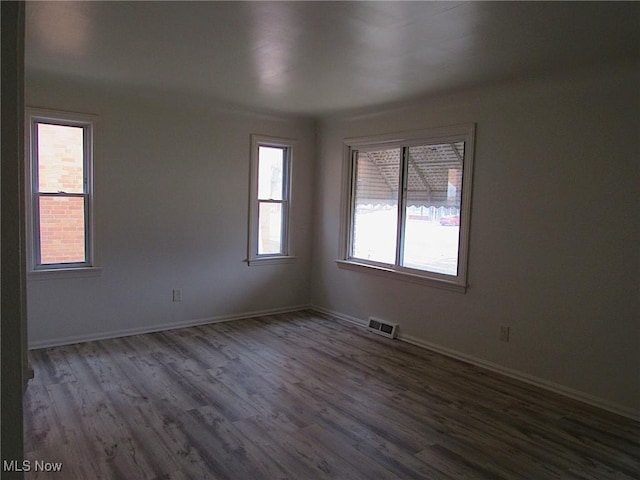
[29,305,311,350]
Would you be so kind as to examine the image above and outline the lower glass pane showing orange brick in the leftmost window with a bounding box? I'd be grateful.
[40,196,86,264]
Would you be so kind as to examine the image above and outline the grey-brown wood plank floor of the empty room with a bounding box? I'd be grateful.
[25,312,640,480]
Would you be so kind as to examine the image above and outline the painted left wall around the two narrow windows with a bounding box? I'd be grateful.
[26,73,315,346]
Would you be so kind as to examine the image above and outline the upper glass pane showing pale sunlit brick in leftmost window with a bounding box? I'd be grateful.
[37,123,84,193]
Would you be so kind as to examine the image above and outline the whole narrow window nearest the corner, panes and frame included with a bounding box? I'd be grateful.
[249,135,293,265]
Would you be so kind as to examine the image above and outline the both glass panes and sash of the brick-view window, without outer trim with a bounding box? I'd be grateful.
[37,123,86,265]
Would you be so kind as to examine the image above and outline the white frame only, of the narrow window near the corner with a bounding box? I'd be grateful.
[247,135,296,266]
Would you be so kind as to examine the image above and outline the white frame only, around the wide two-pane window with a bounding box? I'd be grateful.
[336,123,475,293]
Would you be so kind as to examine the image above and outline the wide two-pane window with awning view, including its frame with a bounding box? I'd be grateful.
[339,125,475,291]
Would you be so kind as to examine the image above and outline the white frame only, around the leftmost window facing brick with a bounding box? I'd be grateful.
[25,107,102,279]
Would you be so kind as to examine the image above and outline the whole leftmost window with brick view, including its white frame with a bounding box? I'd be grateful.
[26,109,95,271]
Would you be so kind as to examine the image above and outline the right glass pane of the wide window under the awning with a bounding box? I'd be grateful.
[402,142,464,276]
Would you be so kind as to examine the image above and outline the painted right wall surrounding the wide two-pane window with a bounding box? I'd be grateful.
[312,65,640,413]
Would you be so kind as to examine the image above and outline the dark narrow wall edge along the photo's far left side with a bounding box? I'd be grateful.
[0,2,27,472]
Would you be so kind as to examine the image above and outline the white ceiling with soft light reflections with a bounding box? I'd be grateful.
[25,1,640,116]
